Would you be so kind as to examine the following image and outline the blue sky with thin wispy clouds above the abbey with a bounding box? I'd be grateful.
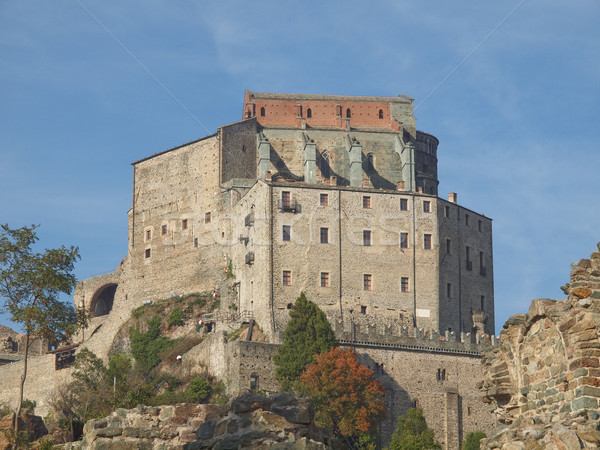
[0,0,600,332]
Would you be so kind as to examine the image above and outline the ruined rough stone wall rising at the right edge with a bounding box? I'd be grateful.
[480,244,600,449]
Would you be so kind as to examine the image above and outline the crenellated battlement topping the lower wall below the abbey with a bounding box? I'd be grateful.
[335,321,498,355]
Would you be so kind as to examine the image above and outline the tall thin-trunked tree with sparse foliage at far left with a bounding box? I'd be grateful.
[0,225,85,433]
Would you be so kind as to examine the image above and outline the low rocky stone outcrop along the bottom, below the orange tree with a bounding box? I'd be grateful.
[63,393,336,450]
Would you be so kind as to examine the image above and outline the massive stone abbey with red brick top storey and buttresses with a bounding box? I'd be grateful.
[0,91,495,448]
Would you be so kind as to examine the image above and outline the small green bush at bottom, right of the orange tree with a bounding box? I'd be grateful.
[390,408,442,450]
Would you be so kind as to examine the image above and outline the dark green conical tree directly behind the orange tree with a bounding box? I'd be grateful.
[273,293,335,390]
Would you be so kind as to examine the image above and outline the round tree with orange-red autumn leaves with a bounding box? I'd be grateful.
[300,348,385,436]
